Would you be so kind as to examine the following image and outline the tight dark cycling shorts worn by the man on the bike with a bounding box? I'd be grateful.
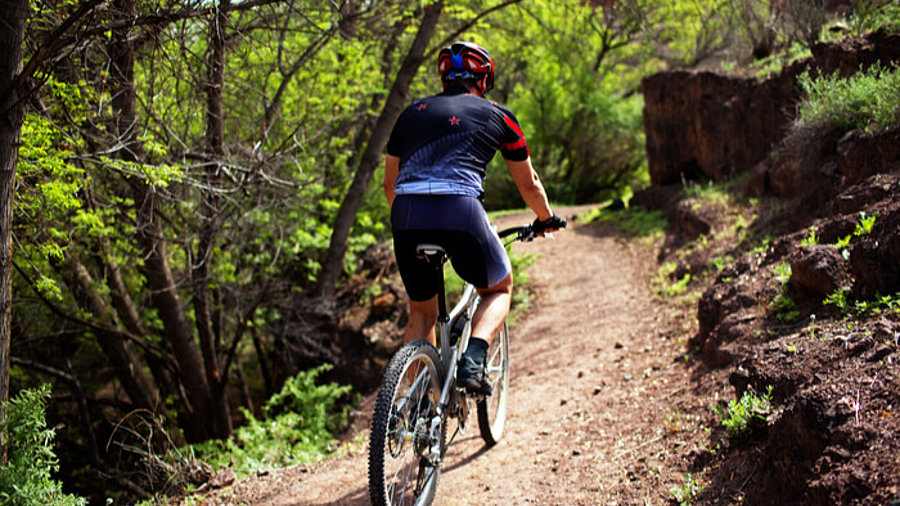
[391,195,512,302]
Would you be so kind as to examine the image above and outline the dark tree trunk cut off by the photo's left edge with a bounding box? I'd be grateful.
[0,0,28,465]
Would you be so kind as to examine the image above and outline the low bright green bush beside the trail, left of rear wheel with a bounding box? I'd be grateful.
[194,365,351,472]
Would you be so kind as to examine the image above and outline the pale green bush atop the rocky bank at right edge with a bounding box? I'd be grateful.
[792,64,900,135]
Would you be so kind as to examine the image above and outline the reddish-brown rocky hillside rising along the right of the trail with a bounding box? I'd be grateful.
[633,32,900,504]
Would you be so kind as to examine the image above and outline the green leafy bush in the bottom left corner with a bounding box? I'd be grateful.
[0,385,87,506]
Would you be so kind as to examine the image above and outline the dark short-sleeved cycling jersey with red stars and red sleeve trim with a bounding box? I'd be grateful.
[387,86,528,198]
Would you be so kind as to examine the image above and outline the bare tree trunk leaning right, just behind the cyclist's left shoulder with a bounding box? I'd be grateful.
[317,0,444,302]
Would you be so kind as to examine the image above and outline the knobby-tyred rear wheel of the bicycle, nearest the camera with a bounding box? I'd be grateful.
[369,341,447,506]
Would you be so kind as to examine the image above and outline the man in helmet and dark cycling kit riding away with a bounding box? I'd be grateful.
[384,42,564,395]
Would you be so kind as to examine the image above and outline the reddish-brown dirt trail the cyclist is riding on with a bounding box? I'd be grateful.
[193,211,703,505]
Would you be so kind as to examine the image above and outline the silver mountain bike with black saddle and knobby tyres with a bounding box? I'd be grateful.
[369,220,565,506]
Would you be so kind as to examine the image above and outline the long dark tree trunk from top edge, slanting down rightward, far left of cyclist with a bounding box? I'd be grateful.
[110,0,213,441]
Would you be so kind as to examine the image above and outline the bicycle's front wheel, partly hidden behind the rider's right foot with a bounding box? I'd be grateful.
[478,322,509,446]
